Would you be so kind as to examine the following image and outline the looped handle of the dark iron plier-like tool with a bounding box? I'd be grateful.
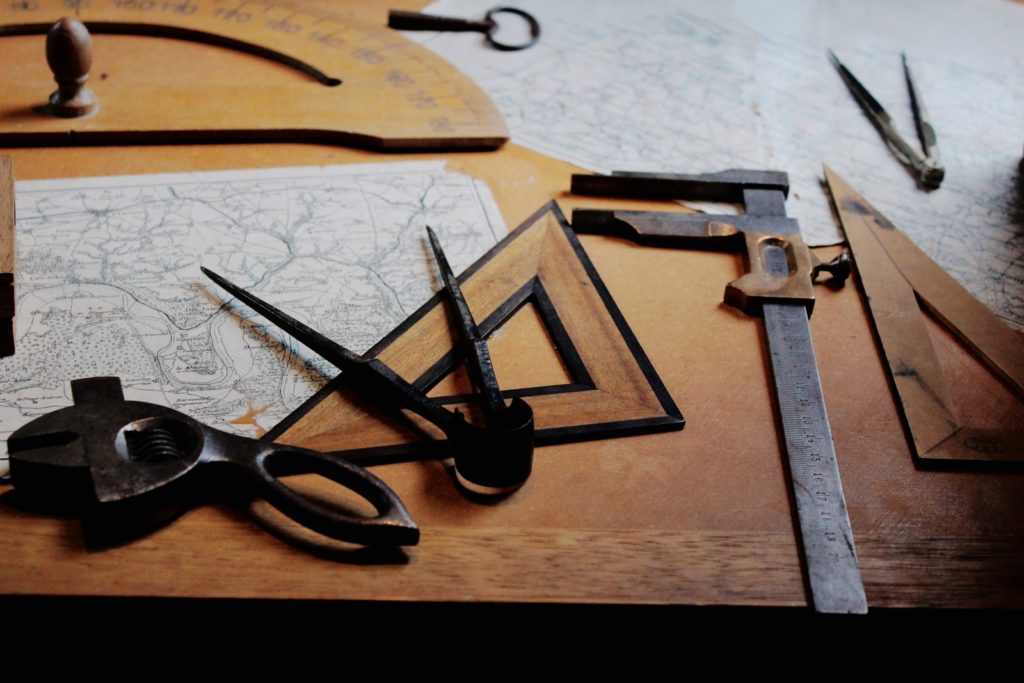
[237,446,420,546]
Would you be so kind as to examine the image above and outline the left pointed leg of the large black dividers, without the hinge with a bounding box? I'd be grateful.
[200,267,456,434]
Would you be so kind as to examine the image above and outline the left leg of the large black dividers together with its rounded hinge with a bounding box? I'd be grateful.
[202,268,534,492]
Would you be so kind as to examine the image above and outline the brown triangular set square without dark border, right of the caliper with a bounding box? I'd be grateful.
[824,166,1024,463]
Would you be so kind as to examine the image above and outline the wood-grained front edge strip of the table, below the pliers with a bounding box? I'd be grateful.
[0,512,1024,609]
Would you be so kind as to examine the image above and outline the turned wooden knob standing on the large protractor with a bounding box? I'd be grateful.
[46,16,99,119]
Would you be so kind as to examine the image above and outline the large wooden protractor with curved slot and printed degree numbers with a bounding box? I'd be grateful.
[0,0,508,150]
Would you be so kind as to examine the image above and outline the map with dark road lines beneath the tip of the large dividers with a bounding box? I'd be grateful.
[0,163,506,471]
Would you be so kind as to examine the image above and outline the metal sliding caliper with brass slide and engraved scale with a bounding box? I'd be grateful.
[572,170,867,613]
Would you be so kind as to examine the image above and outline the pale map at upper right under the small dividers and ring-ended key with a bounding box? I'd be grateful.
[407,0,1024,329]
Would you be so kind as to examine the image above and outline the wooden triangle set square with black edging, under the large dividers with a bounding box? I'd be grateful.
[264,202,684,464]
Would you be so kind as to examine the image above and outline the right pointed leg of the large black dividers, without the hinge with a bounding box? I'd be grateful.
[427,225,506,417]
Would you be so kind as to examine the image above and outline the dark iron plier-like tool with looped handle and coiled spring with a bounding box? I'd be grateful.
[7,377,420,546]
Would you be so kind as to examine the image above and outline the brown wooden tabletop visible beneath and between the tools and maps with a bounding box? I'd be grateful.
[0,0,1024,607]
